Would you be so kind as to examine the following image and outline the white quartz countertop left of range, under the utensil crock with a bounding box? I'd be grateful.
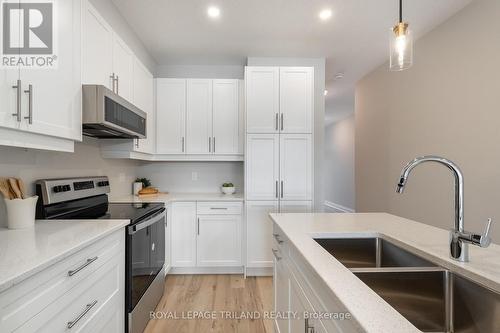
[0,220,130,292]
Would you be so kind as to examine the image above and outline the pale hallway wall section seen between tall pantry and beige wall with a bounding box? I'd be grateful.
[324,113,355,210]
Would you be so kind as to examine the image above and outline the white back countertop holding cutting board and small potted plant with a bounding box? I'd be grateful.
[110,193,243,204]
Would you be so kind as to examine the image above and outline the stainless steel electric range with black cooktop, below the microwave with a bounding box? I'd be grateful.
[36,177,167,333]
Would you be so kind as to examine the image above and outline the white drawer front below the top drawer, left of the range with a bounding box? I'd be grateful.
[16,249,125,333]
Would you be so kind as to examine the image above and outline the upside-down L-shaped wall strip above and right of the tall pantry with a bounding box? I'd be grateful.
[248,57,325,211]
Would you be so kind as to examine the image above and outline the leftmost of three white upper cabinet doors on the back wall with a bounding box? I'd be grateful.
[156,79,186,154]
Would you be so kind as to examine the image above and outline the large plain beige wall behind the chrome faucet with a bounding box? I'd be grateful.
[356,0,500,243]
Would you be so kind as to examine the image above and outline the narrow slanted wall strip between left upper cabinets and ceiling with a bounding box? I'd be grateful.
[89,0,157,74]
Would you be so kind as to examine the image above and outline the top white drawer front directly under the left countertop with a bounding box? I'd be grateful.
[0,230,125,332]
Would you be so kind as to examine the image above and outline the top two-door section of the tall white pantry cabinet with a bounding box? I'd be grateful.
[245,67,314,134]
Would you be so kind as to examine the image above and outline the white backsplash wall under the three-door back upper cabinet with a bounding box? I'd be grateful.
[137,162,243,193]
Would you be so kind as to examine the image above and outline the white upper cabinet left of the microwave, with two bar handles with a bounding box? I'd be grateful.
[0,0,82,151]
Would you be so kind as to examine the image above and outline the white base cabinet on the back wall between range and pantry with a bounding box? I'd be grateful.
[170,202,242,273]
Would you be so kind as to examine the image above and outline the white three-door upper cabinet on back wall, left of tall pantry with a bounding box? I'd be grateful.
[156,79,243,161]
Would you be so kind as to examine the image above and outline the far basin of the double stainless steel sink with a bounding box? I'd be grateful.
[315,238,436,268]
